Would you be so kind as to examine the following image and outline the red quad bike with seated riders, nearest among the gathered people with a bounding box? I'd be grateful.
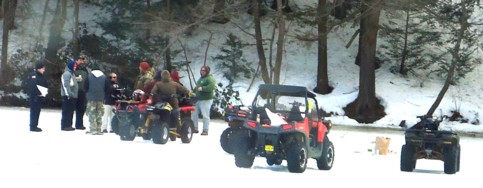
[144,98,195,144]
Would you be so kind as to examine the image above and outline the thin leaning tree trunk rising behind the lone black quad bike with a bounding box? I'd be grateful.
[426,1,469,117]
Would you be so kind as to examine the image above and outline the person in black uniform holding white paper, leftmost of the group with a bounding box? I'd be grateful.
[28,63,47,132]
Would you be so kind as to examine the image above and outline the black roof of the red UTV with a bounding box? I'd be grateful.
[258,84,315,98]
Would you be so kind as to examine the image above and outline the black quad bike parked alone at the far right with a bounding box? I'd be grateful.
[401,116,461,174]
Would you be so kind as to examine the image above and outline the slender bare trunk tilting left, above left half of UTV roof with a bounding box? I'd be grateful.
[251,0,272,84]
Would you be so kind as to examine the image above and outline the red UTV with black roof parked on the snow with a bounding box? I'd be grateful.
[231,84,335,173]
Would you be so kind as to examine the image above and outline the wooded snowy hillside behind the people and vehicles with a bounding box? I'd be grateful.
[0,0,483,123]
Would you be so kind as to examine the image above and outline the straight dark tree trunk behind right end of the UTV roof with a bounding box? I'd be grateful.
[314,0,332,94]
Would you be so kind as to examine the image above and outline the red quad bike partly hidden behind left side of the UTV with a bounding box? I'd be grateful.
[220,100,251,154]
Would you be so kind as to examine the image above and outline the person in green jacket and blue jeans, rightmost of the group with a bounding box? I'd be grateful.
[191,66,216,135]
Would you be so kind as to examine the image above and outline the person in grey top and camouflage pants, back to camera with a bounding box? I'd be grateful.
[84,64,107,135]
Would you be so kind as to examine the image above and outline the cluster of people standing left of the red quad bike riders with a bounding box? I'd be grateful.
[28,56,119,135]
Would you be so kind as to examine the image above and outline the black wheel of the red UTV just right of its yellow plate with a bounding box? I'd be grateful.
[287,142,308,173]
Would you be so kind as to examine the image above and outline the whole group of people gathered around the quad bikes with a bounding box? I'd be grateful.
[28,56,216,135]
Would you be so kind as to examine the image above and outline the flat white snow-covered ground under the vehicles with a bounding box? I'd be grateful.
[0,107,483,188]
